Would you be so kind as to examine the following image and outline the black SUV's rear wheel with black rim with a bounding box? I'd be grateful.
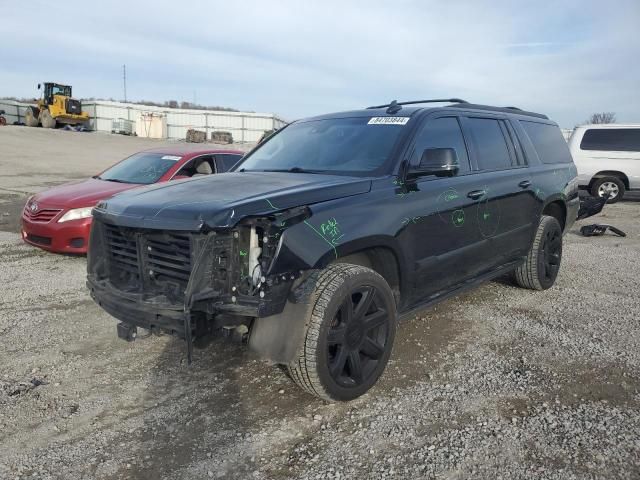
[515,215,562,290]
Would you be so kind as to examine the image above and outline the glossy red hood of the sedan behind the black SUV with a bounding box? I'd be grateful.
[33,178,140,208]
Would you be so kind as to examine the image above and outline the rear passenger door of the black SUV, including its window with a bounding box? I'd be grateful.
[462,114,537,271]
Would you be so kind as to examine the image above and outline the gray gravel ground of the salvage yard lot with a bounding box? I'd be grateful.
[0,127,640,479]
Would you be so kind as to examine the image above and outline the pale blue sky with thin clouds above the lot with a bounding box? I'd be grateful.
[0,0,640,127]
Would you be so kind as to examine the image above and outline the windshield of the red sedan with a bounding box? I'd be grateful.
[96,152,181,184]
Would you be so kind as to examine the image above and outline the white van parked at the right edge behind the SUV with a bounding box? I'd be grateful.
[569,123,640,203]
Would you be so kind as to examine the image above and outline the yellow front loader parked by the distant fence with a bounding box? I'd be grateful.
[25,82,89,128]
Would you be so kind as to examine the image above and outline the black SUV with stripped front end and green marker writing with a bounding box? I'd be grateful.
[88,99,579,400]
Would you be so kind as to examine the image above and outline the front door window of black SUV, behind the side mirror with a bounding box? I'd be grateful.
[412,117,470,172]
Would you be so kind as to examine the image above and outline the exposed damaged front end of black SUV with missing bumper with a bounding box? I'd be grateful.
[87,211,304,362]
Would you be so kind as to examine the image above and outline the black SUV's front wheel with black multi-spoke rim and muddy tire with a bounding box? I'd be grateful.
[287,263,397,401]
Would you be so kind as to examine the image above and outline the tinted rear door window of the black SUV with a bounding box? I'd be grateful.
[467,118,512,170]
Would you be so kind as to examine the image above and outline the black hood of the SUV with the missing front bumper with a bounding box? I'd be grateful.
[94,172,371,231]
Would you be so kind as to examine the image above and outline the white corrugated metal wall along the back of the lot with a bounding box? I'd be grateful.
[0,99,286,142]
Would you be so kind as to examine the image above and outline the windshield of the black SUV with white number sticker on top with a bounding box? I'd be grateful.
[235,117,408,175]
